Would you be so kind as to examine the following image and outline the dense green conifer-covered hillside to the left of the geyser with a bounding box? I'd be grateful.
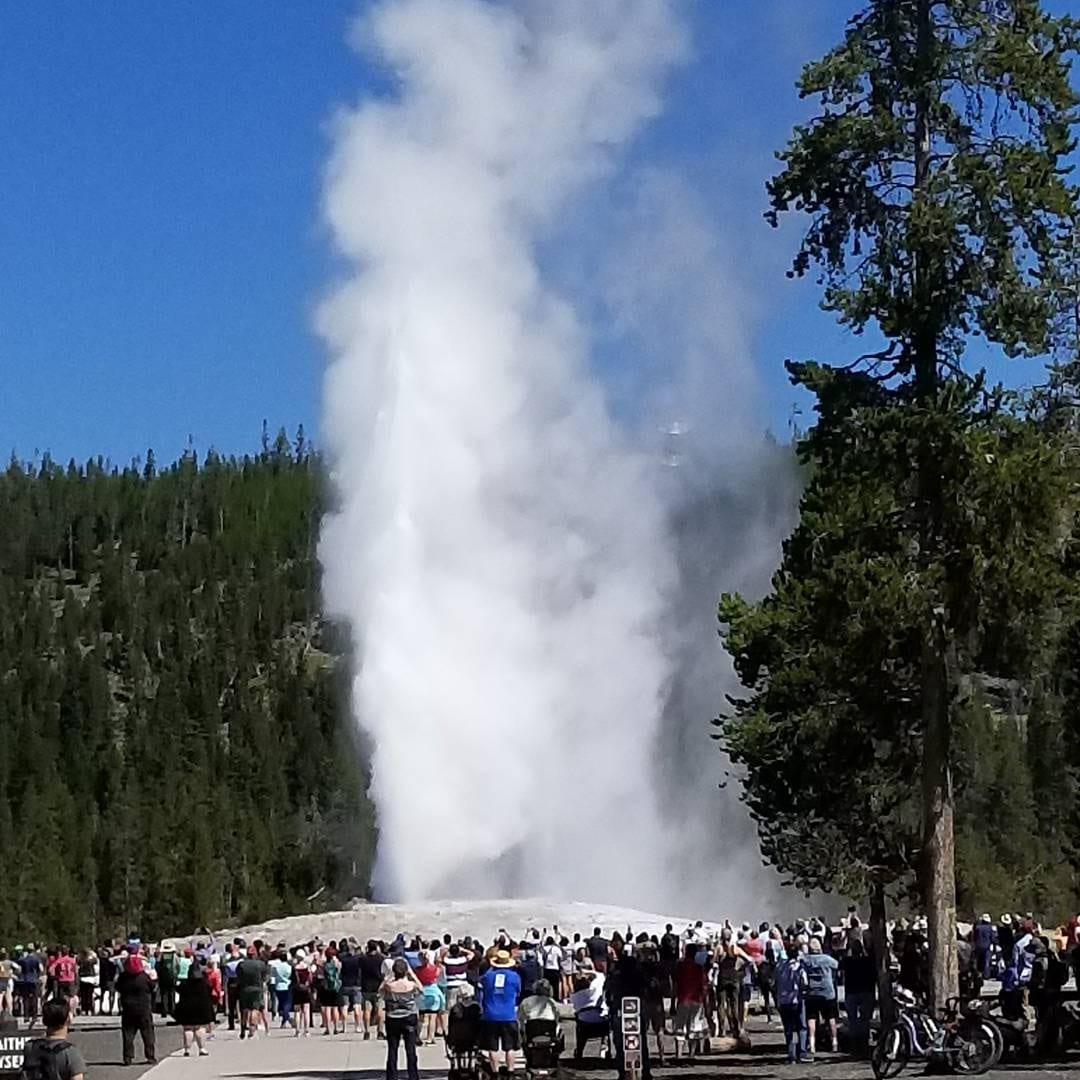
[0,425,374,941]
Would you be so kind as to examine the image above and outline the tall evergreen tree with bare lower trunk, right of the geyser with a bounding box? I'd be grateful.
[721,0,1080,1005]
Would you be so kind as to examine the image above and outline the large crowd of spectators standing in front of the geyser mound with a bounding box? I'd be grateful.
[6,909,1080,1080]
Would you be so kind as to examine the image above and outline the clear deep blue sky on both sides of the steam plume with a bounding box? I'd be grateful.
[0,0,1065,462]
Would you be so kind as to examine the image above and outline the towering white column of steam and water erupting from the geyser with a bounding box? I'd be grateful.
[320,0,790,907]
